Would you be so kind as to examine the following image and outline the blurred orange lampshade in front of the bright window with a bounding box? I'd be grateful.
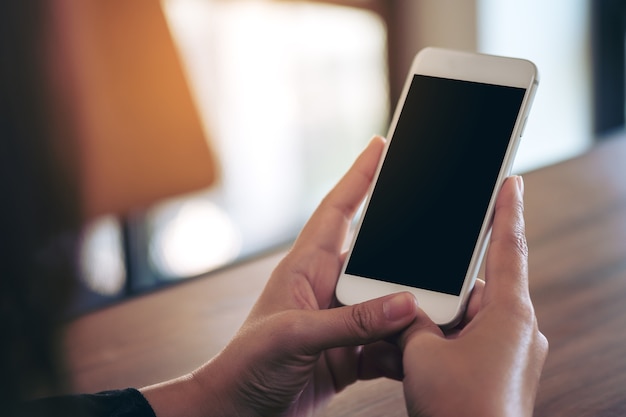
[54,0,216,218]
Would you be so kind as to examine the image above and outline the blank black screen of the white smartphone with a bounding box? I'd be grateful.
[346,75,525,295]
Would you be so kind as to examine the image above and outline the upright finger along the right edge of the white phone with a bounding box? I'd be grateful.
[485,176,528,297]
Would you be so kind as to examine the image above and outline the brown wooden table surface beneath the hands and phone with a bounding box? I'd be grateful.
[66,134,626,417]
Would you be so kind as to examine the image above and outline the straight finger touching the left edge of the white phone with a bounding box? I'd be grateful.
[296,137,385,253]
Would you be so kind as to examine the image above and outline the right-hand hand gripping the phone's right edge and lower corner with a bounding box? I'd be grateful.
[400,177,548,417]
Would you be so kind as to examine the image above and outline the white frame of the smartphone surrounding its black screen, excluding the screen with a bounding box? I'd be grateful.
[336,48,539,328]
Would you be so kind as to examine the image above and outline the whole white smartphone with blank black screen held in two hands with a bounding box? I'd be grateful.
[336,48,539,328]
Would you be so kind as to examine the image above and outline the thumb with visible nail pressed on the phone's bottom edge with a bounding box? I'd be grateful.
[298,292,419,351]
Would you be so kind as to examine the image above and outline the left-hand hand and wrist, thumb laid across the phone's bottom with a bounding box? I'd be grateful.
[142,138,418,417]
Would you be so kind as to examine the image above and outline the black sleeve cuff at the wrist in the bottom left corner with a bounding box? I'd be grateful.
[16,388,156,417]
